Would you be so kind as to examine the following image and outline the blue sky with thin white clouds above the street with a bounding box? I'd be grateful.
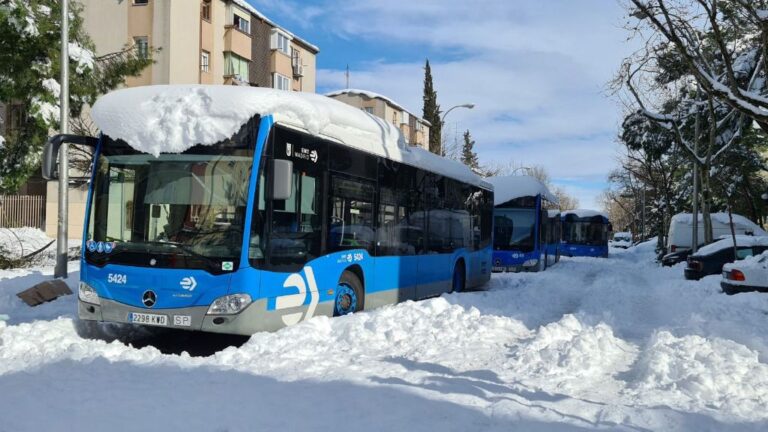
[248,0,632,208]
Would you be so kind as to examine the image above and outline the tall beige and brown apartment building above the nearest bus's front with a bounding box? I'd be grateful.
[77,0,319,92]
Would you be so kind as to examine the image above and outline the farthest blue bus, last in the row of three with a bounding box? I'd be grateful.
[561,210,613,257]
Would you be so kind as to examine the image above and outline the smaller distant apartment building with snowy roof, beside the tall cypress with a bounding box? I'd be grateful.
[326,89,432,150]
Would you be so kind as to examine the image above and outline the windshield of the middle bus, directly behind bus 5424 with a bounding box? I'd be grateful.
[493,208,536,252]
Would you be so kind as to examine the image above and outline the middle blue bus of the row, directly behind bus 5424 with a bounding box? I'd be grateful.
[488,176,560,272]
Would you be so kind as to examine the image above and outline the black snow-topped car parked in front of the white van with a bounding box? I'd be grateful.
[684,235,768,280]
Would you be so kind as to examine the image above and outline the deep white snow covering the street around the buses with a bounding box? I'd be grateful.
[0,241,768,432]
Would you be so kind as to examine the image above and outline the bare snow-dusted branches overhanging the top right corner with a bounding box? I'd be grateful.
[628,0,768,129]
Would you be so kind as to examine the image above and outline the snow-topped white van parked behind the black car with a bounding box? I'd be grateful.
[667,213,768,253]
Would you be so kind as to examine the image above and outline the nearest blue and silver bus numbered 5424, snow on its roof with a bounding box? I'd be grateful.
[43,86,493,335]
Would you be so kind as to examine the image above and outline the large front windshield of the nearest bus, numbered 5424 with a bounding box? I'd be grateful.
[86,120,255,270]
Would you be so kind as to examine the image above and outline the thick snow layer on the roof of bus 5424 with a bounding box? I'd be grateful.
[92,85,491,188]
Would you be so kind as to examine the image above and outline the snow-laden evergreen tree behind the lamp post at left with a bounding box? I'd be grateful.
[0,0,152,192]
